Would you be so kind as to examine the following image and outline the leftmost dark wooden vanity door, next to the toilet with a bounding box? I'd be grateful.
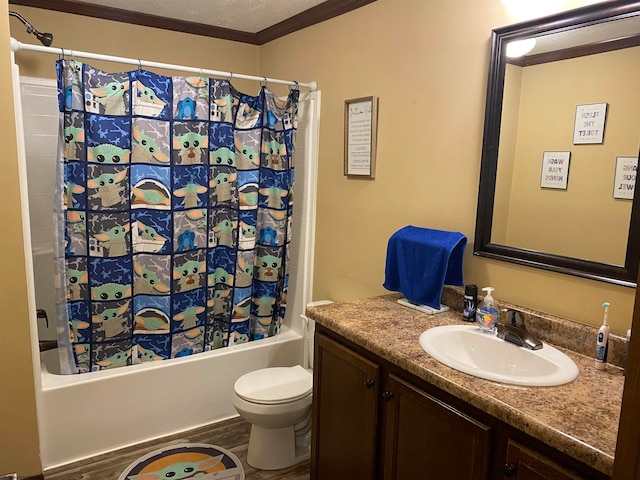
[311,334,380,480]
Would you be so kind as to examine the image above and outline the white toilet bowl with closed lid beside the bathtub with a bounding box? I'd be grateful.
[232,365,313,470]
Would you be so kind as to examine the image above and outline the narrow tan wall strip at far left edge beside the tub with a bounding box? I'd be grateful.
[0,0,40,475]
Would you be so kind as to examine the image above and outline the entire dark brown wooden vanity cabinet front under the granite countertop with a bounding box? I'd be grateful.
[311,324,609,480]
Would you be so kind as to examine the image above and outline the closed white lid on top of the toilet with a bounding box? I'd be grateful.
[234,365,313,405]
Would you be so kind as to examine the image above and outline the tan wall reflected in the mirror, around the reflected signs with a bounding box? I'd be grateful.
[500,47,640,265]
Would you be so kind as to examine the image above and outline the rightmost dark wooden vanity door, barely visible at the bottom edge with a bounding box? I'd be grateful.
[504,440,586,480]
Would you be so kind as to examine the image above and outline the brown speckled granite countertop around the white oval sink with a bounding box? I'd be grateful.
[307,295,624,475]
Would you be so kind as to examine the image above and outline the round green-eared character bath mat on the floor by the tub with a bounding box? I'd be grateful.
[118,443,244,480]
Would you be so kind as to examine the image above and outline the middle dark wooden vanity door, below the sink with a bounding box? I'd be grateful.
[382,375,492,480]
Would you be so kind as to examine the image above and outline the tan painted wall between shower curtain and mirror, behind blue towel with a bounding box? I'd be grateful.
[260,0,634,332]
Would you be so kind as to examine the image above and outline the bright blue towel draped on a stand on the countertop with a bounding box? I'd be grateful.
[383,225,467,309]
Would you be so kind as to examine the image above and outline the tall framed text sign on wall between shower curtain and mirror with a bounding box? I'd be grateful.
[344,97,378,178]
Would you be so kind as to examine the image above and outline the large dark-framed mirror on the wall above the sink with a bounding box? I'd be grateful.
[474,0,640,287]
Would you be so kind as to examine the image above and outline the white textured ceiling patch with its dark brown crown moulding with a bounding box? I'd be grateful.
[9,0,375,45]
